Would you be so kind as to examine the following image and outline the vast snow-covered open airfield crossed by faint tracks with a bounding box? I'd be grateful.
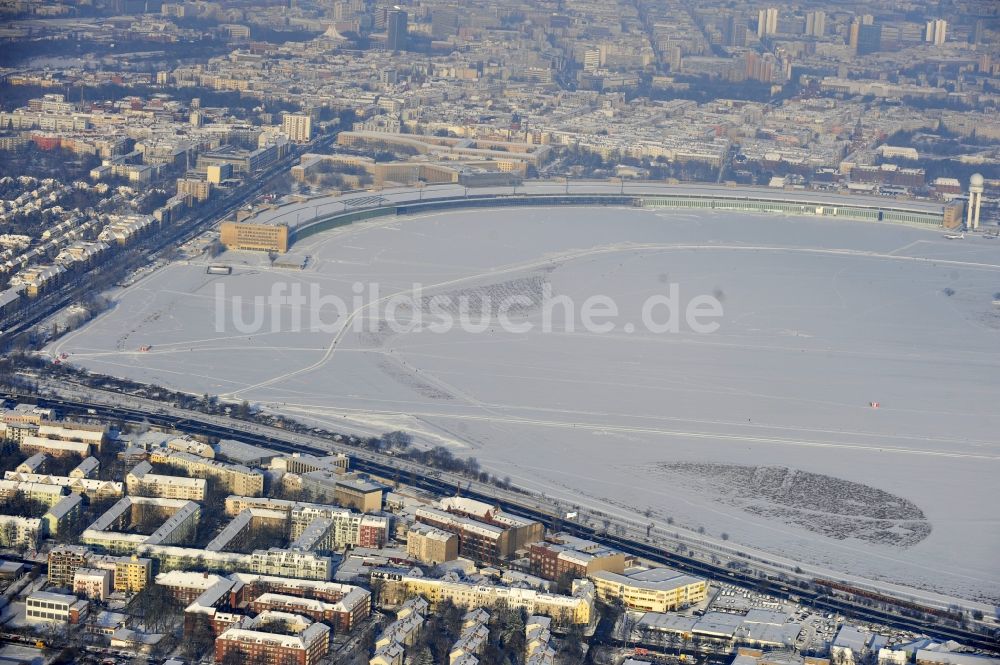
[50,208,1000,599]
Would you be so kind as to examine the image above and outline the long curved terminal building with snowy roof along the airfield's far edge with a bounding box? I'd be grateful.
[274,183,945,239]
